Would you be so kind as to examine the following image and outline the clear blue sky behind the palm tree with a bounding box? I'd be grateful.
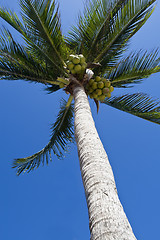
[0,0,160,240]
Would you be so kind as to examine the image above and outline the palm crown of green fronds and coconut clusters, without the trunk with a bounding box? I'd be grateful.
[0,0,160,175]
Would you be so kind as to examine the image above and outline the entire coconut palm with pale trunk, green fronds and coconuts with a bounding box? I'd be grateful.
[0,0,160,240]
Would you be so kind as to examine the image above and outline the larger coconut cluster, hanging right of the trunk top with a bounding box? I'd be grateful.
[86,76,114,101]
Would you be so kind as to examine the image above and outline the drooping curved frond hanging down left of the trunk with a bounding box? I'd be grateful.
[13,97,73,175]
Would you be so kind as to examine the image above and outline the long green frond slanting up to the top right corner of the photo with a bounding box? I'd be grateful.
[95,0,155,65]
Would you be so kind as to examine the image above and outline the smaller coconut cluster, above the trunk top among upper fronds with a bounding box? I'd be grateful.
[66,54,87,75]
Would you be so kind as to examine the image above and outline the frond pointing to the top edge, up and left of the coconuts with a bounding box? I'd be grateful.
[20,0,64,66]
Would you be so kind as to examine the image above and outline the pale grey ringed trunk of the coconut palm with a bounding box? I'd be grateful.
[73,86,136,240]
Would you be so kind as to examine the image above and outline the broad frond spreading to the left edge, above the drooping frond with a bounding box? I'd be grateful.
[0,29,59,87]
